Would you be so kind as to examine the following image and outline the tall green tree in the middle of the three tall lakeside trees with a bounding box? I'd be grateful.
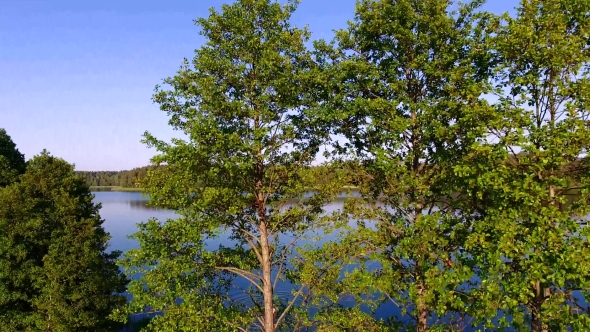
[301,0,496,331]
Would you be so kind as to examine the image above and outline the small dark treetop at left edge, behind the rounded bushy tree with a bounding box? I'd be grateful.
[0,128,25,187]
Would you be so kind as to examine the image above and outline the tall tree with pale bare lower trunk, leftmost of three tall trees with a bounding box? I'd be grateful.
[123,0,338,332]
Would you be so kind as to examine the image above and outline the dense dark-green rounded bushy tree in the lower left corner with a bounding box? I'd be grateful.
[0,151,127,332]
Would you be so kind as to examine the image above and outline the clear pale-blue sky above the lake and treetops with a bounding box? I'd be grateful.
[0,0,516,170]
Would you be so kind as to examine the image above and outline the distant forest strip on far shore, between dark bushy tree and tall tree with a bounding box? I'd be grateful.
[76,165,158,188]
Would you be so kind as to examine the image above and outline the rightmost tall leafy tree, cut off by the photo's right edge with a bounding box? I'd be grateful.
[457,0,590,331]
